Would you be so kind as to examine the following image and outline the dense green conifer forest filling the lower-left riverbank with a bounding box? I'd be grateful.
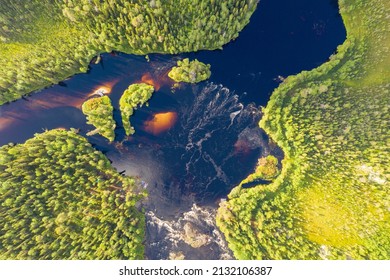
[0,130,145,259]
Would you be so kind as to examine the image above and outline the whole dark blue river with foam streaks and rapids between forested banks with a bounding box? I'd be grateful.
[0,0,345,259]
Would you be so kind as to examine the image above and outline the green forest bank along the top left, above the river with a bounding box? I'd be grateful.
[0,0,258,105]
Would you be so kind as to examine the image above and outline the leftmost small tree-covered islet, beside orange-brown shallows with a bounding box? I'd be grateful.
[82,96,116,141]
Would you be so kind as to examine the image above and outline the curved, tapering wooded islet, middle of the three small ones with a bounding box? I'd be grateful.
[119,83,154,135]
